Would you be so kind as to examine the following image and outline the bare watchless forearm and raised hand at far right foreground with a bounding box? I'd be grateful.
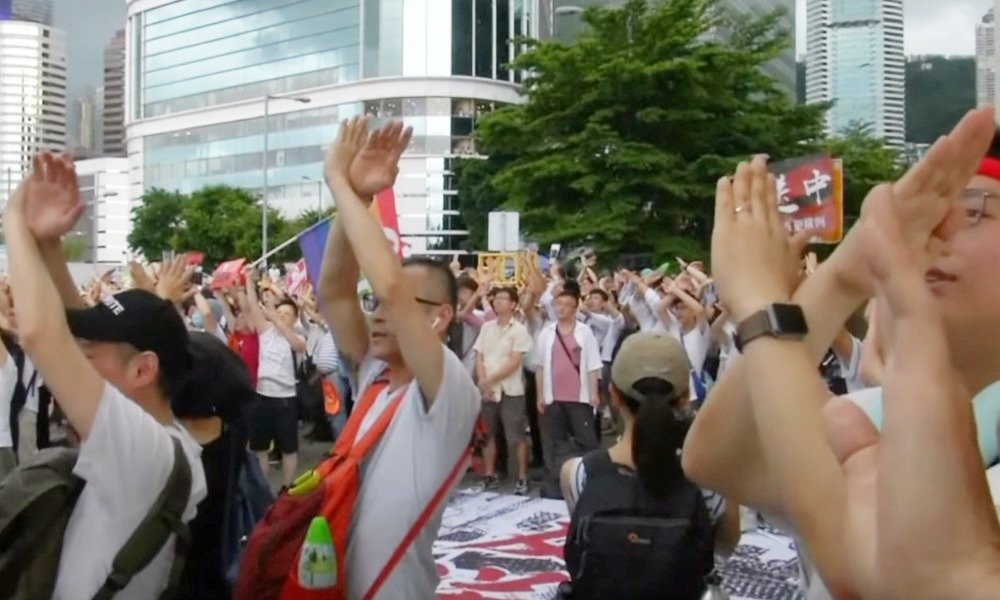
[826,186,1000,599]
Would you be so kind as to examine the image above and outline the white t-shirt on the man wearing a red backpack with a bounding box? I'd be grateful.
[346,348,480,600]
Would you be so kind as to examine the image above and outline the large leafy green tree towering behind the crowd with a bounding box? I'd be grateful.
[457,0,825,258]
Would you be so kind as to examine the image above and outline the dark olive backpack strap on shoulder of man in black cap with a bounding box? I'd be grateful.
[94,436,191,600]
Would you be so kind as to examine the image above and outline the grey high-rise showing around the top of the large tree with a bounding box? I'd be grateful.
[539,0,797,98]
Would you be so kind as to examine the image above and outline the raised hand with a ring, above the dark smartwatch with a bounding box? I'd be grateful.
[712,156,808,322]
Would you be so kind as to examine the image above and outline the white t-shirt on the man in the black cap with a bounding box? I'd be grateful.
[52,385,207,600]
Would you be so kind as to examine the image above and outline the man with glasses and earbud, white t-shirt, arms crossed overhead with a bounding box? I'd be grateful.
[318,119,480,600]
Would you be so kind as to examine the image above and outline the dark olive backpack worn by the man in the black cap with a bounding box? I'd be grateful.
[0,436,191,600]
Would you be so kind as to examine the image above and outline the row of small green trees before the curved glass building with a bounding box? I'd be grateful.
[128,186,327,265]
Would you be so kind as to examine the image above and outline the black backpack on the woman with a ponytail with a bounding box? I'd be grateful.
[564,450,715,600]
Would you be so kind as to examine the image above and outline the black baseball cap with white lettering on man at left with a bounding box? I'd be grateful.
[66,289,192,382]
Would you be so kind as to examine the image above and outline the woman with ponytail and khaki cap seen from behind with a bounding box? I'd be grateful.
[560,332,740,598]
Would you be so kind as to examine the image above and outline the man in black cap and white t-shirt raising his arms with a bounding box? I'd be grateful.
[4,154,206,600]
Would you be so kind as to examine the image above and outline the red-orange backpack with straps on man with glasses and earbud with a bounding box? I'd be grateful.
[233,376,469,600]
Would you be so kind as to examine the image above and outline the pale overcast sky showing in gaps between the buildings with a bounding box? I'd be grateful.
[55,0,992,103]
